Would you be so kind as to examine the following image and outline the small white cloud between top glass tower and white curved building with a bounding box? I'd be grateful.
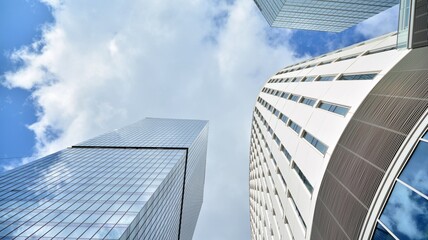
[356,5,398,38]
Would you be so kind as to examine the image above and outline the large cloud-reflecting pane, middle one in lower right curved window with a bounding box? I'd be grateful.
[380,182,428,240]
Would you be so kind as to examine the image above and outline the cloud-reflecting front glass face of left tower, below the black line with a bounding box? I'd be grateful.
[0,148,186,239]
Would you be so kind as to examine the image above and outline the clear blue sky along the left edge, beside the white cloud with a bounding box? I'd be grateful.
[0,0,53,171]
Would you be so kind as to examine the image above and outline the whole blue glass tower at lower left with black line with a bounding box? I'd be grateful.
[0,118,208,239]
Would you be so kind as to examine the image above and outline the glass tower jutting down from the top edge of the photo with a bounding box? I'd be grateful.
[254,0,398,32]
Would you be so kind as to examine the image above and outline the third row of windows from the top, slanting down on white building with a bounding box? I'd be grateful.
[262,87,349,116]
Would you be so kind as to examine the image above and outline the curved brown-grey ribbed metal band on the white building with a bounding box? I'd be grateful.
[311,48,428,240]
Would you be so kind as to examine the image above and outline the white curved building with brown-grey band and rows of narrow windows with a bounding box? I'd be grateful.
[249,29,428,240]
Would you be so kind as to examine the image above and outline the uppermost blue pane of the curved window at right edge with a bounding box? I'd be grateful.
[399,141,428,196]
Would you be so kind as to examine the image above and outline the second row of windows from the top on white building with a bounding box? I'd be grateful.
[268,73,377,83]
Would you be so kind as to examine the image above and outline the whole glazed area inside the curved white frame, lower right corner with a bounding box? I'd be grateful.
[373,129,428,240]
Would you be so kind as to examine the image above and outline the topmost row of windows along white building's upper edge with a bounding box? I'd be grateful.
[275,44,397,75]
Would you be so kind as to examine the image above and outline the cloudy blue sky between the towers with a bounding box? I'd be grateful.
[0,0,398,240]
